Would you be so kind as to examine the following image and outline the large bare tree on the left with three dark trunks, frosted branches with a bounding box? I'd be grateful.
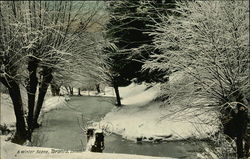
[0,1,103,141]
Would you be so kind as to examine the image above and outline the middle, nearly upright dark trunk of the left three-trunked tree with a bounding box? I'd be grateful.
[26,59,38,133]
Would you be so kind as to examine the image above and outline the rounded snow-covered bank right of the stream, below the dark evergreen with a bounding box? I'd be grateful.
[97,83,218,141]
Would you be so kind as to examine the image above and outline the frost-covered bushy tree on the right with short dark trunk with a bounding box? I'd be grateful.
[144,1,250,157]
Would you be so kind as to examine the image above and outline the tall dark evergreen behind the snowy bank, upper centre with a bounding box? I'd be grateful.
[105,0,174,105]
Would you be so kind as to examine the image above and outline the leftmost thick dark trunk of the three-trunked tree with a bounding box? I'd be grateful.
[8,81,27,143]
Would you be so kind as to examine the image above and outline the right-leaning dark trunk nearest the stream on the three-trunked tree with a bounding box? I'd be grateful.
[34,69,53,128]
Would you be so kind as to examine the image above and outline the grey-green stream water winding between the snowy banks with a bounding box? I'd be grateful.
[32,97,203,158]
